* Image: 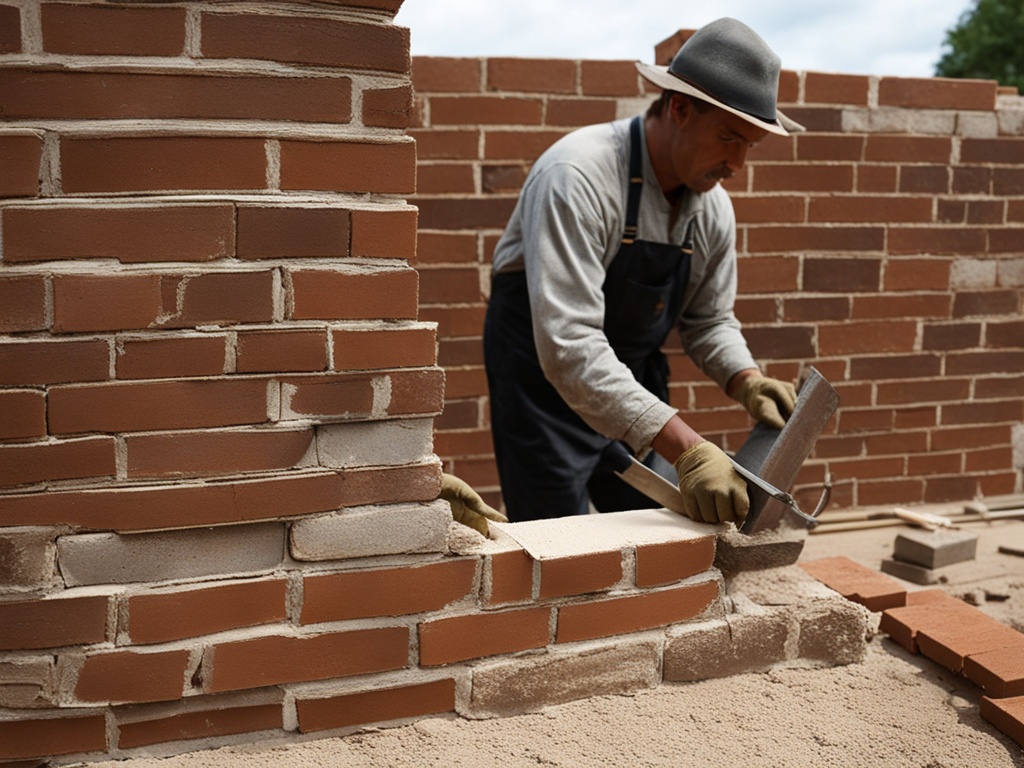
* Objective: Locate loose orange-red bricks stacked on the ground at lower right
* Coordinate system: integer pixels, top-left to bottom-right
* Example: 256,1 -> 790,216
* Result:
801,557 -> 1024,746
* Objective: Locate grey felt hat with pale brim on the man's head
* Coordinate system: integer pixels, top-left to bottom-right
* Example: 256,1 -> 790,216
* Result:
637,18 -> 804,136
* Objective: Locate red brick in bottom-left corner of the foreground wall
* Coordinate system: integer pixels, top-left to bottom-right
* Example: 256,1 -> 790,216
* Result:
0,714 -> 106,765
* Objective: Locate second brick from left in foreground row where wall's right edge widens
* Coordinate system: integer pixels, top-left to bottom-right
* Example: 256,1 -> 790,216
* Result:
116,335 -> 227,379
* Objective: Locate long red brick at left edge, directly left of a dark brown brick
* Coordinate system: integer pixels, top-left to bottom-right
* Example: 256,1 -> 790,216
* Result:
3,205 -> 234,263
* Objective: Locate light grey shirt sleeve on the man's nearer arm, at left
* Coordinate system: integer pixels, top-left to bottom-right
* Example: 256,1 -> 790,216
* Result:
521,163 -> 676,454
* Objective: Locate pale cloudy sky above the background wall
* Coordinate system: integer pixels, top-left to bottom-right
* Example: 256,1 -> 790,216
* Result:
395,0 -> 974,77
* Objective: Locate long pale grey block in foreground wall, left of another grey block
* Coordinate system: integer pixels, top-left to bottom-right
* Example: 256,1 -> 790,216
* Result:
57,522 -> 285,587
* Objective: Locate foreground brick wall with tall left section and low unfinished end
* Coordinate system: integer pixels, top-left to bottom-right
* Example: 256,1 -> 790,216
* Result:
0,6 -> 864,766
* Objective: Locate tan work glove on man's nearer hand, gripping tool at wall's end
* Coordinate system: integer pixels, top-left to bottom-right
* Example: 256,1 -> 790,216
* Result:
675,440 -> 751,523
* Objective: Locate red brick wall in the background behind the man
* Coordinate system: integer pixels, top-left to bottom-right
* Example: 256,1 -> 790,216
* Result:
411,46 -> 1024,507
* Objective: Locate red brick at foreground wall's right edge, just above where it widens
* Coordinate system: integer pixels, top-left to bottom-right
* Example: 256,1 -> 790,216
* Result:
289,269 -> 419,319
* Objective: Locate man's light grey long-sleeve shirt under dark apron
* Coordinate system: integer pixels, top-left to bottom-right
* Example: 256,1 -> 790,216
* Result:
494,120 -> 757,454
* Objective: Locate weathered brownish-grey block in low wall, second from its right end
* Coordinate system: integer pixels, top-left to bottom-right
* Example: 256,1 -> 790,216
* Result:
665,609 -> 790,682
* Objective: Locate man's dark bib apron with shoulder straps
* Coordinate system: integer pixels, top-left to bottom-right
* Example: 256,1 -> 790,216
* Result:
483,117 -> 693,521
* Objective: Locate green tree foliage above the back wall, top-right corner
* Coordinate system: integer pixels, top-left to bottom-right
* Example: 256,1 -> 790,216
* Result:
935,0 -> 1024,92
